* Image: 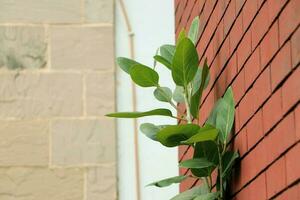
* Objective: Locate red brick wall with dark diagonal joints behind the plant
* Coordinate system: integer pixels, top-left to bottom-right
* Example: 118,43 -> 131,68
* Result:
175,0 -> 300,200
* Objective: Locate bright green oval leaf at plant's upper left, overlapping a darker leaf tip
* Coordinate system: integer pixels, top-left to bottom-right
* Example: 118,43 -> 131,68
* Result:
130,65 -> 159,87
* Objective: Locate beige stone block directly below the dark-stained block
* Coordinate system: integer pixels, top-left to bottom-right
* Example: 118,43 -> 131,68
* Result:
0,73 -> 83,119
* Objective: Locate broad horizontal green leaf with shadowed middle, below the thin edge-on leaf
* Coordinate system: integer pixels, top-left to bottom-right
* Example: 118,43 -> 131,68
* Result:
156,124 -> 200,147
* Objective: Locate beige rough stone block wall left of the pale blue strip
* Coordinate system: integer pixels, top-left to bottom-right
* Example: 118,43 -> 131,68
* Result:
0,0 -> 116,200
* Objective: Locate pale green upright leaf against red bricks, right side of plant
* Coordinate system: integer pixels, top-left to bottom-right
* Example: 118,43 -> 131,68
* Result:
216,88 -> 234,142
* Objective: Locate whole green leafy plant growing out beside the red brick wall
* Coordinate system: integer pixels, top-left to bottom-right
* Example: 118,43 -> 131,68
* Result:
106,17 -> 239,200
